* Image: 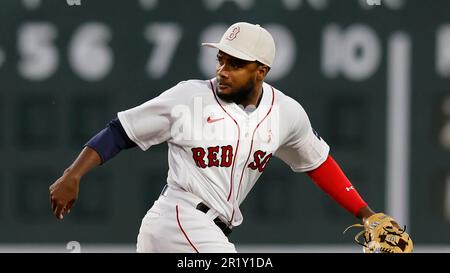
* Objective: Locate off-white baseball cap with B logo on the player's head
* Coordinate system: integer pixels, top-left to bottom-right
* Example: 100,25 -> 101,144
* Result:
202,22 -> 275,66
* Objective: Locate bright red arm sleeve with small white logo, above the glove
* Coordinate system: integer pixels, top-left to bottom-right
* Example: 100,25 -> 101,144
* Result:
306,155 -> 367,215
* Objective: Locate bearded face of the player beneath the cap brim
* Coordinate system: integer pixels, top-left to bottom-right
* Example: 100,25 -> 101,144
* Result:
216,51 -> 266,102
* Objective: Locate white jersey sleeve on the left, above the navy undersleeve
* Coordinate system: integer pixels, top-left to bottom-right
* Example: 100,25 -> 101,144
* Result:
117,83 -> 183,151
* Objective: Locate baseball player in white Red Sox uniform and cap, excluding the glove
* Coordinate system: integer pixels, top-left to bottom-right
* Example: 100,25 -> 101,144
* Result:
49,22 -> 374,252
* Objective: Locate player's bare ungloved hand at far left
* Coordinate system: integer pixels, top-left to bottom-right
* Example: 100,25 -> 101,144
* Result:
49,172 -> 80,220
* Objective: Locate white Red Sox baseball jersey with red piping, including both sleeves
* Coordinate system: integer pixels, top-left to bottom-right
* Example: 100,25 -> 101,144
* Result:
118,79 -> 329,226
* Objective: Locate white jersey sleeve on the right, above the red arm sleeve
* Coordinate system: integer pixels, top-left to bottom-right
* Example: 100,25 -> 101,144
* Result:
275,101 -> 330,172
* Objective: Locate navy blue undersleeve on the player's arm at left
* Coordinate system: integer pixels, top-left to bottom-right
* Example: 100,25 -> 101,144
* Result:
84,118 -> 137,164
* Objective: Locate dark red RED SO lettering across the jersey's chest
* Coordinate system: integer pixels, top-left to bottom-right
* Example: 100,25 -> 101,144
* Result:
191,145 -> 272,173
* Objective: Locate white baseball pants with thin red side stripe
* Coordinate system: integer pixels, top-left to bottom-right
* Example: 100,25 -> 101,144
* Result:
137,184 -> 236,253
